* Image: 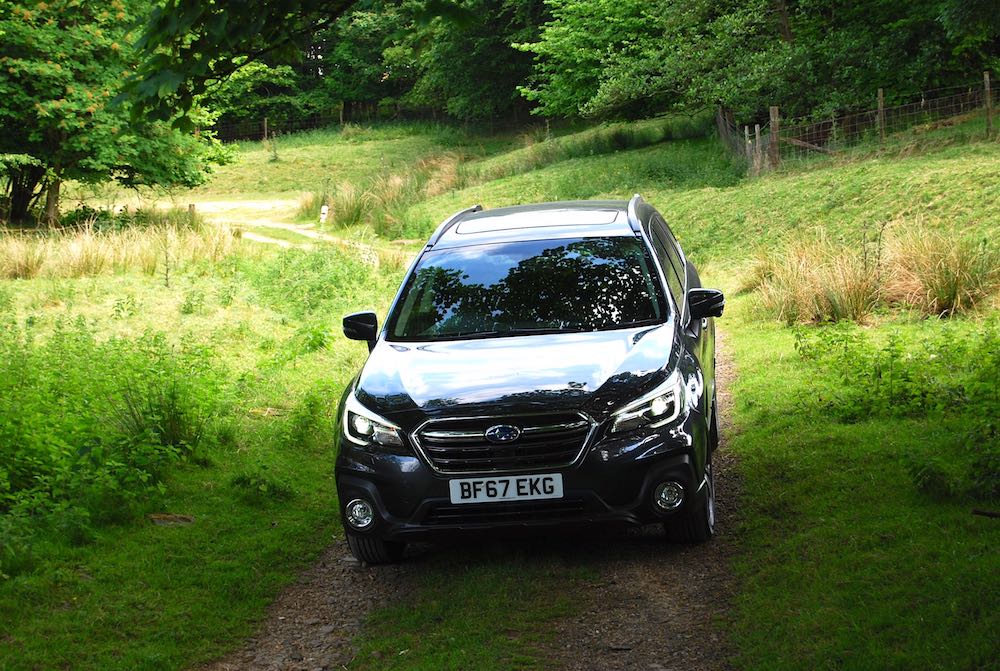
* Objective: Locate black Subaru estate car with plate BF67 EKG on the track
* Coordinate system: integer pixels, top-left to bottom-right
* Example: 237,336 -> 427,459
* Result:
336,195 -> 725,563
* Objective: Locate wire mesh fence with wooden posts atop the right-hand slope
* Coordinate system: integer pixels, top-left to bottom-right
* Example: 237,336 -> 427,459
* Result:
716,74 -> 1000,174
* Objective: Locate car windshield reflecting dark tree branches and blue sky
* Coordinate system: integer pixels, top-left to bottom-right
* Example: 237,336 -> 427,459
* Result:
389,237 -> 667,340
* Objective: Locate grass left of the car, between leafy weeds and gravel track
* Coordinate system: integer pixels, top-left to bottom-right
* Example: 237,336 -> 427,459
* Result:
0,249 -> 406,669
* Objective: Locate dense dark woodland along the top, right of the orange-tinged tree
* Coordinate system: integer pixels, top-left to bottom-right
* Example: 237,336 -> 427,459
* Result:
127,0 -> 1000,128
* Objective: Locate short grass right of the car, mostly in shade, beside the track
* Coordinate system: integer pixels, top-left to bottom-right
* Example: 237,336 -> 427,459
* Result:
726,299 -> 1000,670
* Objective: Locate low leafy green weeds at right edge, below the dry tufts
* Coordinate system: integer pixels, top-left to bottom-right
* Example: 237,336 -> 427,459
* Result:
795,320 -> 1000,500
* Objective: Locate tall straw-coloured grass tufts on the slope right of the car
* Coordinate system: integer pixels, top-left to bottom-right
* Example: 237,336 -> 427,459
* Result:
742,222 -> 1000,323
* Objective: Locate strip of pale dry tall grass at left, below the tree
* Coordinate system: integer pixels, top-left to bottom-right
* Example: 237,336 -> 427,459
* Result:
0,217 -> 239,279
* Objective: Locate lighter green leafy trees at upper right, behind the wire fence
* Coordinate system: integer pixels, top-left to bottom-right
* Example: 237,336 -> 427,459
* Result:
523,0 -> 1000,120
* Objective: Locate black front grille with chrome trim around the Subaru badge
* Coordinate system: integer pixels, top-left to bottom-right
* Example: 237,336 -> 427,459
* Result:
415,412 -> 591,473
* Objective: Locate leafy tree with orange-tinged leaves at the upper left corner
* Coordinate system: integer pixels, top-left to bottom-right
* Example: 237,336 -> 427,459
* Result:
0,0 -> 223,222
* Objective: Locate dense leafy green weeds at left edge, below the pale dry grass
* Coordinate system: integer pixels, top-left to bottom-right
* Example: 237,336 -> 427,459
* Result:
0,317 -> 223,573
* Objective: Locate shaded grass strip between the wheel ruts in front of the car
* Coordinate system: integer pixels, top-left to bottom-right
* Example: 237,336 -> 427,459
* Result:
350,546 -> 590,671
